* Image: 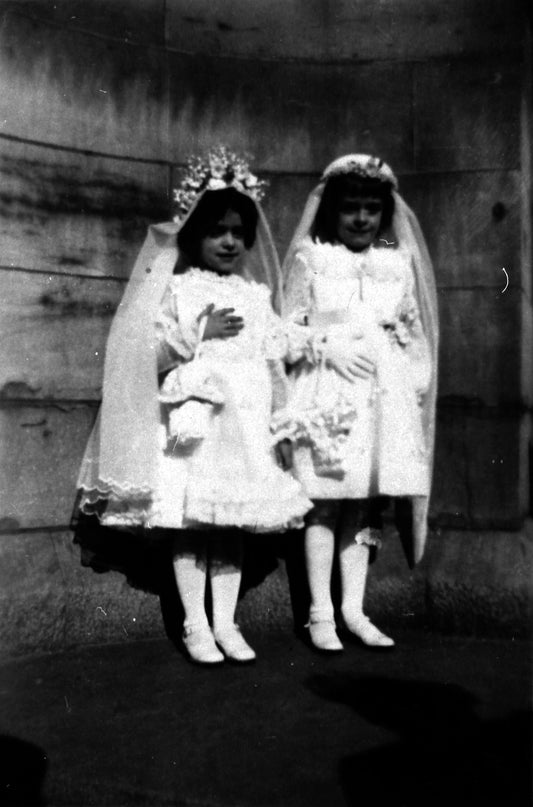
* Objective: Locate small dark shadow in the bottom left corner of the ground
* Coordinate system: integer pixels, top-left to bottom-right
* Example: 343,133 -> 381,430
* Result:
0,734 -> 48,807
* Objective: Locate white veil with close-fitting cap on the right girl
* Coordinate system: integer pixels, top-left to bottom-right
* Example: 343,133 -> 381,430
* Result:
281,154 -> 439,563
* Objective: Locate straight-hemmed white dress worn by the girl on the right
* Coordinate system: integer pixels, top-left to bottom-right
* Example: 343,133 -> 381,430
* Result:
278,237 -> 432,499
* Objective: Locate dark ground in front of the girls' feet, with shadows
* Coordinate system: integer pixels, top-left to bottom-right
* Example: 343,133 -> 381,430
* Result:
0,631 -> 532,807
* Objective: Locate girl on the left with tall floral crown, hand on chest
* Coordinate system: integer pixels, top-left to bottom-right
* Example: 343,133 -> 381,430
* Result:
79,147 -> 311,664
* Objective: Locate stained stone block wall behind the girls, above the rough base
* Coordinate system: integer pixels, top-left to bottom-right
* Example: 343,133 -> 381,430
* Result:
0,0 -> 531,652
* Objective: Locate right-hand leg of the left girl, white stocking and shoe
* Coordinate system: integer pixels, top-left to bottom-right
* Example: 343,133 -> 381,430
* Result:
209,531 -> 255,663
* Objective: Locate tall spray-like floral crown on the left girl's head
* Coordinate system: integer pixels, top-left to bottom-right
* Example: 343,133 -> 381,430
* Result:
174,146 -> 268,222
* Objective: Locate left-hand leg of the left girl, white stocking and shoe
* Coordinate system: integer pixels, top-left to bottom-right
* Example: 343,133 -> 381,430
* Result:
172,533 -> 224,664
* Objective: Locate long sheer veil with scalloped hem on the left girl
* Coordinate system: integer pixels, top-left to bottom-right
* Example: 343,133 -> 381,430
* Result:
77,190 -> 281,512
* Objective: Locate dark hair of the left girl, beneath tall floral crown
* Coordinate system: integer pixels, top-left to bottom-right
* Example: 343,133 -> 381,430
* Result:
178,188 -> 258,263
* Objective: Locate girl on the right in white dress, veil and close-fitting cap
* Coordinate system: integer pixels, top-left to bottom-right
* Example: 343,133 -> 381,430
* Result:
275,154 -> 437,651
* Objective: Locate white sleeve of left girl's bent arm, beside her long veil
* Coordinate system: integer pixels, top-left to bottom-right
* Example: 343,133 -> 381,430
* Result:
155,278 -> 201,373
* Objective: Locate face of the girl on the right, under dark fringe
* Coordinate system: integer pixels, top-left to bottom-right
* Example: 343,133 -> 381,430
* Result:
337,193 -> 383,252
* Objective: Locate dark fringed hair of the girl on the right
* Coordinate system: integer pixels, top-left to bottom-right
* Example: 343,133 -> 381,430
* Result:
311,174 -> 394,243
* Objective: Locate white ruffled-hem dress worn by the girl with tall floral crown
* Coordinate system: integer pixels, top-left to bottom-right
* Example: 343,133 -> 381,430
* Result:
101,268 -> 311,532
